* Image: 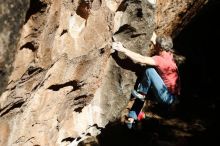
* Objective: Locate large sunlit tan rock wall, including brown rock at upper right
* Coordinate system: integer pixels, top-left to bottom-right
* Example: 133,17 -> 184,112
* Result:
0,0 -> 205,146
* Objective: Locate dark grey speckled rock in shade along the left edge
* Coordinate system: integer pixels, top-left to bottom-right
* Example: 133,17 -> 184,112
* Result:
0,0 -> 29,95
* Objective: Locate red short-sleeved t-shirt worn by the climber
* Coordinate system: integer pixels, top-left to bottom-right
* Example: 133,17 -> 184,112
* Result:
152,51 -> 180,95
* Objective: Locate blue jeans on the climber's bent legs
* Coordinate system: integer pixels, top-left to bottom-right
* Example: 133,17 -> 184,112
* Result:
137,68 -> 175,104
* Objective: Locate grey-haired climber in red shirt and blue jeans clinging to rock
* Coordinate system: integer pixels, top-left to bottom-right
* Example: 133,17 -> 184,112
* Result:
112,33 -> 180,128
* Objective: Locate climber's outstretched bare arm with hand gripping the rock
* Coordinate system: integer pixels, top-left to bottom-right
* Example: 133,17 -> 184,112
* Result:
112,42 -> 156,66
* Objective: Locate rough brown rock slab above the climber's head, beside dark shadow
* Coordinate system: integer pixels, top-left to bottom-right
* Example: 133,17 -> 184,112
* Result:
156,0 -> 208,37
